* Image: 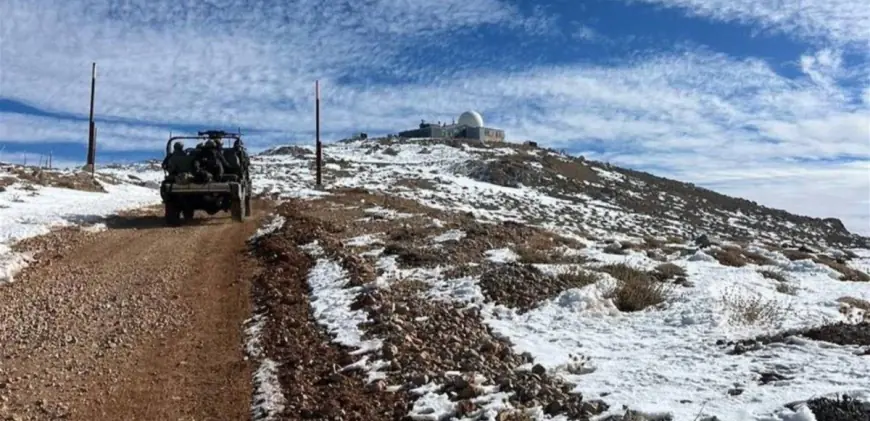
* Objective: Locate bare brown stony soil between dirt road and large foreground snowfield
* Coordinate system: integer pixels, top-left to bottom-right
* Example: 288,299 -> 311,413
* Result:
254,198 -> 607,420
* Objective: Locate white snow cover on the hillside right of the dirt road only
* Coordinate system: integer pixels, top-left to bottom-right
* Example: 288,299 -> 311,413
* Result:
254,141 -> 870,420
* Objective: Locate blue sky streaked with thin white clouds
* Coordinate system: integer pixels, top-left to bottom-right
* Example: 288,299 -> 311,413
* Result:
0,0 -> 870,234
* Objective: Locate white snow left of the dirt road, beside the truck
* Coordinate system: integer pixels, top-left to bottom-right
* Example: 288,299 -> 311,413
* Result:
0,174 -> 160,283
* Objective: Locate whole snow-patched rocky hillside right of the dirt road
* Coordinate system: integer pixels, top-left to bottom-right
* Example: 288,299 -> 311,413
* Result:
58,136 -> 870,421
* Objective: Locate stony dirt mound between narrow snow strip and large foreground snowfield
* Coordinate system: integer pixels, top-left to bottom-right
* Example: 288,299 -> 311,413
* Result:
368,281 -> 608,420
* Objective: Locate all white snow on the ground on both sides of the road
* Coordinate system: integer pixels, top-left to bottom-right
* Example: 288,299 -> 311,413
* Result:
0,142 -> 870,421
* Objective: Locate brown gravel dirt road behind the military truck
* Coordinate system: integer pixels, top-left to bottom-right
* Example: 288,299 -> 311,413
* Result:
0,204 -> 265,421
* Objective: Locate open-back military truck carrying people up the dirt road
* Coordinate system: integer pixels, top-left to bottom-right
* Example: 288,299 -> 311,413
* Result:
160,130 -> 251,226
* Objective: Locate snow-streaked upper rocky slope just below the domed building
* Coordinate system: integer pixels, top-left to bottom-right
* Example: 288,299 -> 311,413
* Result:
260,139 -> 868,249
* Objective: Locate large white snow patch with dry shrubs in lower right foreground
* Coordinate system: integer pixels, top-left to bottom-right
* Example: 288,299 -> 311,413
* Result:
483,251 -> 870,421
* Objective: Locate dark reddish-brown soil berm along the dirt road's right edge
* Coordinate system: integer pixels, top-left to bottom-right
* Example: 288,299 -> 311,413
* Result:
245,205 -> 410,421
